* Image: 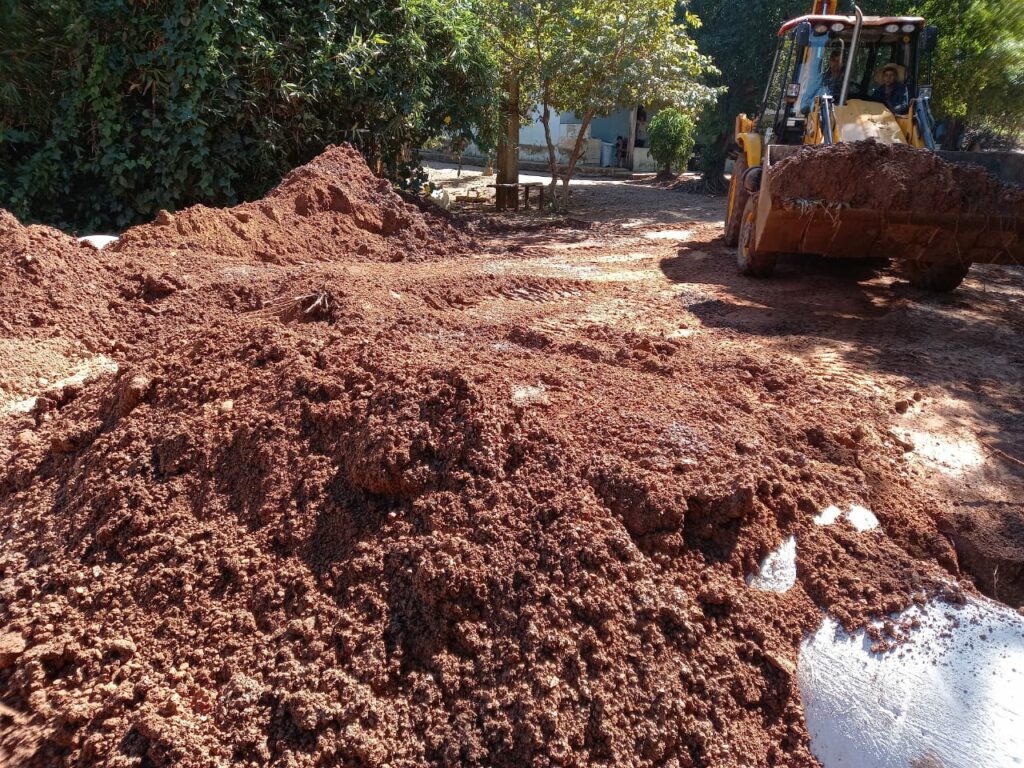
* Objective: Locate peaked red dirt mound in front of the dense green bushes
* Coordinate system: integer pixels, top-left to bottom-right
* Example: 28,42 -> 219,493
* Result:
0,145 -> 471,358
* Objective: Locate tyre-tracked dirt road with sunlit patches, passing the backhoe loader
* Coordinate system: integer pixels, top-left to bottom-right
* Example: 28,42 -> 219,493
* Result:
433,164 -> 1024,606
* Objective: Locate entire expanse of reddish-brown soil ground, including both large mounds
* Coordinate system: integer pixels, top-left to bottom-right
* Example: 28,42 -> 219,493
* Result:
0,147 -> 1024,768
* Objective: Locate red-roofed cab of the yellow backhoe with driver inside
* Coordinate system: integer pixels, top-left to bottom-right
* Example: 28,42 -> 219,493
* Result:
756,13 -> 936,148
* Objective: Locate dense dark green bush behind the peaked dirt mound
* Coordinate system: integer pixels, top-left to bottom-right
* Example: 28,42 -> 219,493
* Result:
0,0 -> 494,229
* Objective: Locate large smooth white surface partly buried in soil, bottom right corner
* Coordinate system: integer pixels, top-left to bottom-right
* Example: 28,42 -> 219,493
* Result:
797,599 -> 1024,768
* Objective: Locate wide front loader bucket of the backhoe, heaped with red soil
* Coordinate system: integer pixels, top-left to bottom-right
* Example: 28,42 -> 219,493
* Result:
754,141 -> 1024,272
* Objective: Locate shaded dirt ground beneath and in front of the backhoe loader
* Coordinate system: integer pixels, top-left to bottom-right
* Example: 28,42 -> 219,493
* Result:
662,243 -> 1024,606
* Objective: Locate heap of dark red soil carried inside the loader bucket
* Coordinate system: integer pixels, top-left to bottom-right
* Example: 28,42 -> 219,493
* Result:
770,140 -> 1024,214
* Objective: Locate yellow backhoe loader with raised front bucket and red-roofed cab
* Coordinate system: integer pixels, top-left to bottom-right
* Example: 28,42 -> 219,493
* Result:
726,0 -> 1024,291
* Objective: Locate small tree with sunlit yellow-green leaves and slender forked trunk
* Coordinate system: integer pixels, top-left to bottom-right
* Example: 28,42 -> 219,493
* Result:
543,0 -> 717,207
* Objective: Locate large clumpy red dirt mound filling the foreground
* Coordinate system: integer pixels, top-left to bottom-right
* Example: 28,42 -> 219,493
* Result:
0,309 -> 958,766
